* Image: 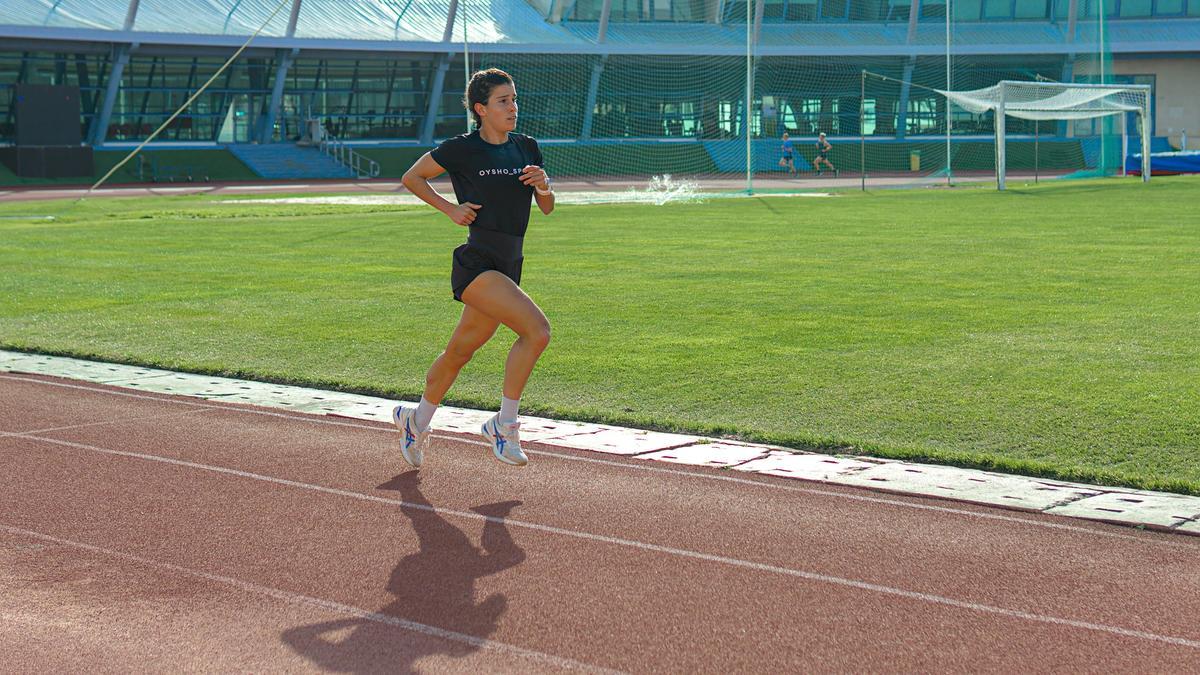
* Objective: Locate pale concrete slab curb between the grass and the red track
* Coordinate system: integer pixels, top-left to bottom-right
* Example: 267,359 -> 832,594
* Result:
0,351 -> 1200,536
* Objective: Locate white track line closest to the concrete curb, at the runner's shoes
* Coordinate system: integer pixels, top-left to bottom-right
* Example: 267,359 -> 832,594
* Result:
0,374 -> 1200,550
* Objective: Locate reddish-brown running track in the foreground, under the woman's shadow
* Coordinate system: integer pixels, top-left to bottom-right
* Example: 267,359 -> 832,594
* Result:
0,375 -> 1200,673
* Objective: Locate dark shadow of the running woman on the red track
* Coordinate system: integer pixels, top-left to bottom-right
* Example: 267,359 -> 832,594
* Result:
282,471 -> 526,673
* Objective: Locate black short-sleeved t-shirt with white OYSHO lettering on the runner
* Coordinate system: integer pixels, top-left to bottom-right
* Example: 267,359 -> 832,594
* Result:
430,130 -> 544,237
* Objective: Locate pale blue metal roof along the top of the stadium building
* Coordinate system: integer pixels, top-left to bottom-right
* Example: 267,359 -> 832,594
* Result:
0,0 -> 1200,56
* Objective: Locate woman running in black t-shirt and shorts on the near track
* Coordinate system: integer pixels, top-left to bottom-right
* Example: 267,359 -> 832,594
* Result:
391,68 -> 554,466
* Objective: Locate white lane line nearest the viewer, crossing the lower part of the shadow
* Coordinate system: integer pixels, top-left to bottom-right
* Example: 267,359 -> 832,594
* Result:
0,524 -> 620,673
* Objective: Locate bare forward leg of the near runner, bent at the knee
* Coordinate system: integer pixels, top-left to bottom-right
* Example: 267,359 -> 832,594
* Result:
458,270 -> 550,400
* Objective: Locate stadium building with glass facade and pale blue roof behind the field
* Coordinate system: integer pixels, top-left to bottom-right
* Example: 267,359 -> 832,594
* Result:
0,0 -> 1200,181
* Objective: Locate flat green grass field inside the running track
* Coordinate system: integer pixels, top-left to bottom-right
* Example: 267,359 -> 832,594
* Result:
0,178 -> 1200,494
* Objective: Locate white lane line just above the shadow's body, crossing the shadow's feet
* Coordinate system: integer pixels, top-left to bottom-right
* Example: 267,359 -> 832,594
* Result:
14,427 -> 1200,650
